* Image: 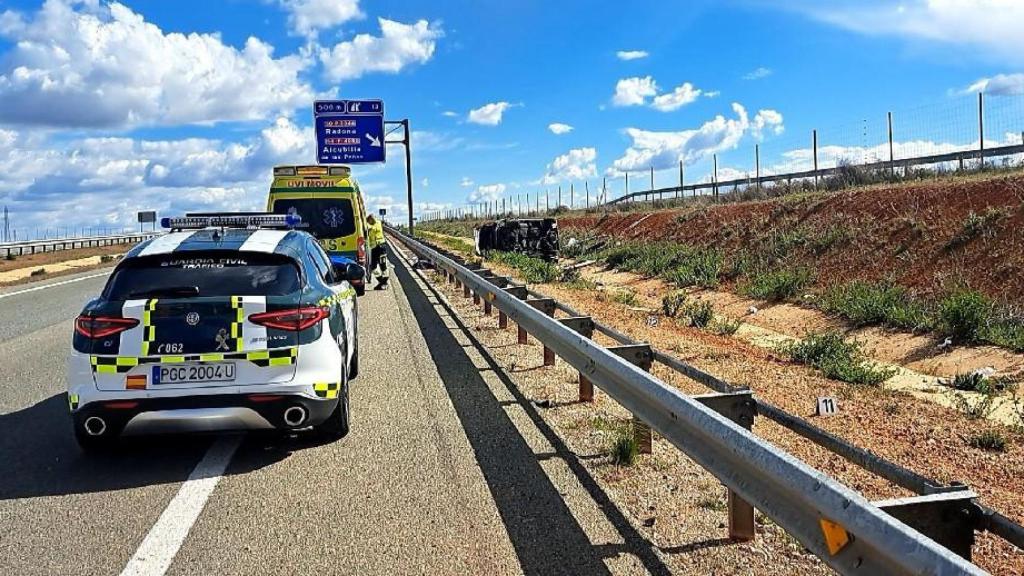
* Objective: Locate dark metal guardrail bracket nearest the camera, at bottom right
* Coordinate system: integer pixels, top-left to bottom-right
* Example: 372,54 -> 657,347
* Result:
871,486 -> 978,560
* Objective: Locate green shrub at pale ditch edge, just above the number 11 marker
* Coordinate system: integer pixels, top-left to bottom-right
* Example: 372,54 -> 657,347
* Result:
780,330 -> 895,385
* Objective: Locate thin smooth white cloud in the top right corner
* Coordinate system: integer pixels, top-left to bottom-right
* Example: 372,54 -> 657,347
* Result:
786,0 -> 1024,64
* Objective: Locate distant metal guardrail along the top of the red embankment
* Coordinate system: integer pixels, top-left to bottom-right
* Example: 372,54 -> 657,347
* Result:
596,145 -> 1024,206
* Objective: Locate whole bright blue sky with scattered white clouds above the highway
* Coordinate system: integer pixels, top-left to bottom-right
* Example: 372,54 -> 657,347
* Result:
0,0 -> 1024,234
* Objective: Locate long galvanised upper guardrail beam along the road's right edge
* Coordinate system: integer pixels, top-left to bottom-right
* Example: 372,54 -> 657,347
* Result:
389,229 -> 985,575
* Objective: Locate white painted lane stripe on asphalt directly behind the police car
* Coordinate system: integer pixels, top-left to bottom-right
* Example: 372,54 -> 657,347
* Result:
121,435 -> 242,576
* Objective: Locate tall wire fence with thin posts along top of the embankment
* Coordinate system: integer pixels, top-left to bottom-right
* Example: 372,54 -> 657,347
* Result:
423,93 -> 1024,220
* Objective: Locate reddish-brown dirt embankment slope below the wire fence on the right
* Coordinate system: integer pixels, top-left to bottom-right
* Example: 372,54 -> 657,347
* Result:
559,175 -> 1024,306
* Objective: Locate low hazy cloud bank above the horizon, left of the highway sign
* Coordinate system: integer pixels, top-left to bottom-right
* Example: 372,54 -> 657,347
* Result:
0,118 -> 313,231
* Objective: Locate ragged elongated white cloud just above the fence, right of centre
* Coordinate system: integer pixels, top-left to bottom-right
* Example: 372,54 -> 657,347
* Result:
608,102 -> 782,175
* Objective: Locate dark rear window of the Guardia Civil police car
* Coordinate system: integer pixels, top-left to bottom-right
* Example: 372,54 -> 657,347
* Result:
104,250 -> 302,300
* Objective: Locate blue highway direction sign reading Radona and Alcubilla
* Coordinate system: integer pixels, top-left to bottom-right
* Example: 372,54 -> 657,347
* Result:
313,100 -> 385,164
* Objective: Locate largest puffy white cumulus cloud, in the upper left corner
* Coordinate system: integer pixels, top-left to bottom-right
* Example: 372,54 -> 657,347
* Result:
0,0 -> 312,128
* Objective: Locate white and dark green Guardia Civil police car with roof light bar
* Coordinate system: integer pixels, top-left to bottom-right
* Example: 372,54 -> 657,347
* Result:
68,214 -> 365,450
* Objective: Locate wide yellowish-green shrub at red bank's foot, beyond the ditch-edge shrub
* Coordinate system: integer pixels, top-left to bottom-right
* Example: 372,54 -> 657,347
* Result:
818,281 -> 930,330
